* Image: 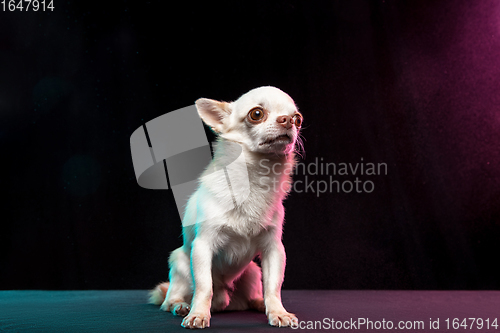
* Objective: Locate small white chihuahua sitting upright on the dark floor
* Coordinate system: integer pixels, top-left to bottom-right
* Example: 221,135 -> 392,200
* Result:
150,87 -> 302,328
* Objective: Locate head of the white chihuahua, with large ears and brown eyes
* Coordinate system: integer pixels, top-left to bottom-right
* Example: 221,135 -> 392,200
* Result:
196,87 -> 303,155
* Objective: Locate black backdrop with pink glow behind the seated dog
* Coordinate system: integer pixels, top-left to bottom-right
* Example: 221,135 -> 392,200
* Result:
0,0 -> 500,289
